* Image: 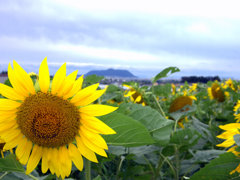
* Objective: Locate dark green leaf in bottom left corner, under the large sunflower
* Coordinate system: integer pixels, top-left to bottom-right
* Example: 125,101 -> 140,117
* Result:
0,154 -> 25,173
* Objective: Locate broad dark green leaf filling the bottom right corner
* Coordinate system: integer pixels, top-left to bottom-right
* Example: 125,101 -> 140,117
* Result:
191,153 -> 240,180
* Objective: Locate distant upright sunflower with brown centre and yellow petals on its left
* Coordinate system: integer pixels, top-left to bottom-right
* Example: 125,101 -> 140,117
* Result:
208,82 -> 227,102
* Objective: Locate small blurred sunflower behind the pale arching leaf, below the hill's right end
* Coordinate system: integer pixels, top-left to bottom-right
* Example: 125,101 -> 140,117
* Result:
123,84 -> 146,106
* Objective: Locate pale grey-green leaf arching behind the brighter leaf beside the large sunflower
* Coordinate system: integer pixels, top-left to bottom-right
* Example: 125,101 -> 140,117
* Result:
118,104 -> 174,145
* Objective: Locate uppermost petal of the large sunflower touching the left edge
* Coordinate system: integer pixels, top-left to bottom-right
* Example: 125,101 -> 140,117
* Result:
0,83 -> 25,100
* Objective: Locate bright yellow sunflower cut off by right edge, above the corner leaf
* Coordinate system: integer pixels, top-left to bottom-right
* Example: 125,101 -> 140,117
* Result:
217,123 -> 240,174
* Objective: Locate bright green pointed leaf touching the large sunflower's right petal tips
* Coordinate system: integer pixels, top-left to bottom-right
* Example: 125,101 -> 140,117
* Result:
100,112 -> 155,147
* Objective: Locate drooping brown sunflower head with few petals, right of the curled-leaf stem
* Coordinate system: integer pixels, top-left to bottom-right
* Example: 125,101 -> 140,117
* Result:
168,95 -> 196,128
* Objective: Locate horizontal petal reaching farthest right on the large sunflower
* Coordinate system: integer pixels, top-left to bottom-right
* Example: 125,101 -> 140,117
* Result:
79,104 -> 118,116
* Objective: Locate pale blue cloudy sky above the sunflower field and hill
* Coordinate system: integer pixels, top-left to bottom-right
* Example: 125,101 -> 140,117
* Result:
0,0 -> 240,79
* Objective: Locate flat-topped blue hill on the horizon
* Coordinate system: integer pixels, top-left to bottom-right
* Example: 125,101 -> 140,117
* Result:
86,69 -> 136,78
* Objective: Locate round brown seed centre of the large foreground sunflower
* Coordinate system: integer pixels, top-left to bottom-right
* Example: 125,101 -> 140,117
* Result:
17,92 -> 80,147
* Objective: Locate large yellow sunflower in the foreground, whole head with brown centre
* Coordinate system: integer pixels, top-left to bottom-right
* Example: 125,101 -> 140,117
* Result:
0,58 -> 117,178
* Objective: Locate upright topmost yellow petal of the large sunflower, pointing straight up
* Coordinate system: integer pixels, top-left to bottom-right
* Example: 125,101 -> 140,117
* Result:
38,57 -> 50,93
